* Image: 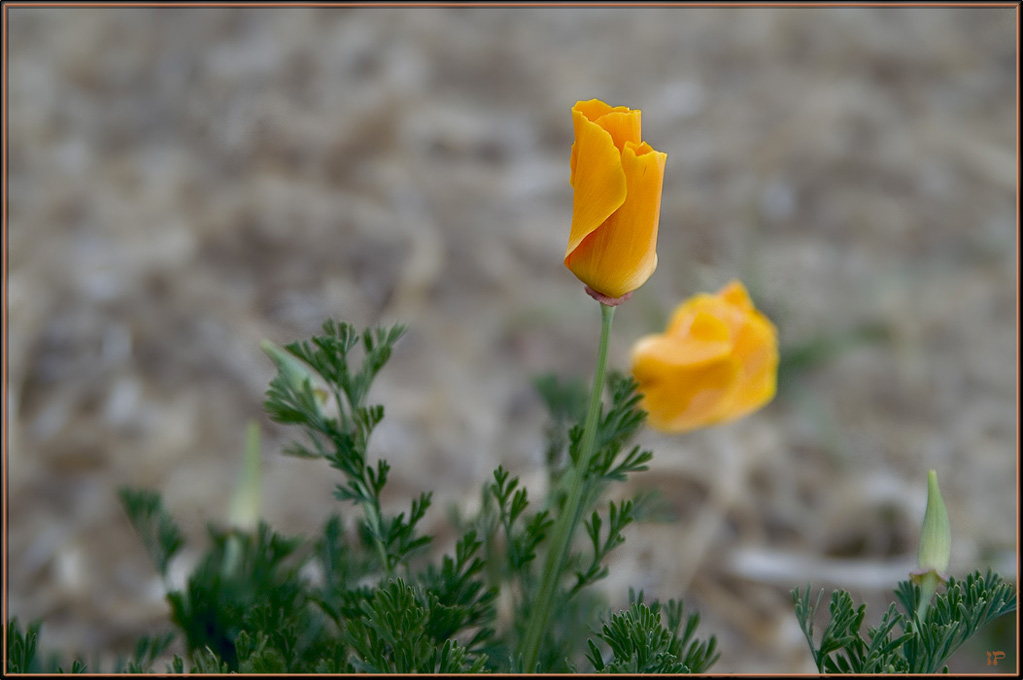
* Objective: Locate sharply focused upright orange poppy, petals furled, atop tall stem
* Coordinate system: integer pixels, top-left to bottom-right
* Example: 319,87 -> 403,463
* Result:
565,99 -> 668,298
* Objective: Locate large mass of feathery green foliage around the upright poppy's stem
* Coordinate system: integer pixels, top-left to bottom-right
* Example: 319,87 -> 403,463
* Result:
7,321 -> 716,675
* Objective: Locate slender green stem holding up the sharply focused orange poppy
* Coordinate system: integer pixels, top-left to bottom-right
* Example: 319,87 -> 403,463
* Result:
521,303 -> 615,673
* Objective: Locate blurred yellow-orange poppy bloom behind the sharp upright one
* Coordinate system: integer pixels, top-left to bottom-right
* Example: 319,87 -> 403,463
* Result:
632,280 -> 777,433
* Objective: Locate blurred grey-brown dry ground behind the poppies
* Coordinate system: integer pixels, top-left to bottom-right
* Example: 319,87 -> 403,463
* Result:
5,6 -> 1018,673
